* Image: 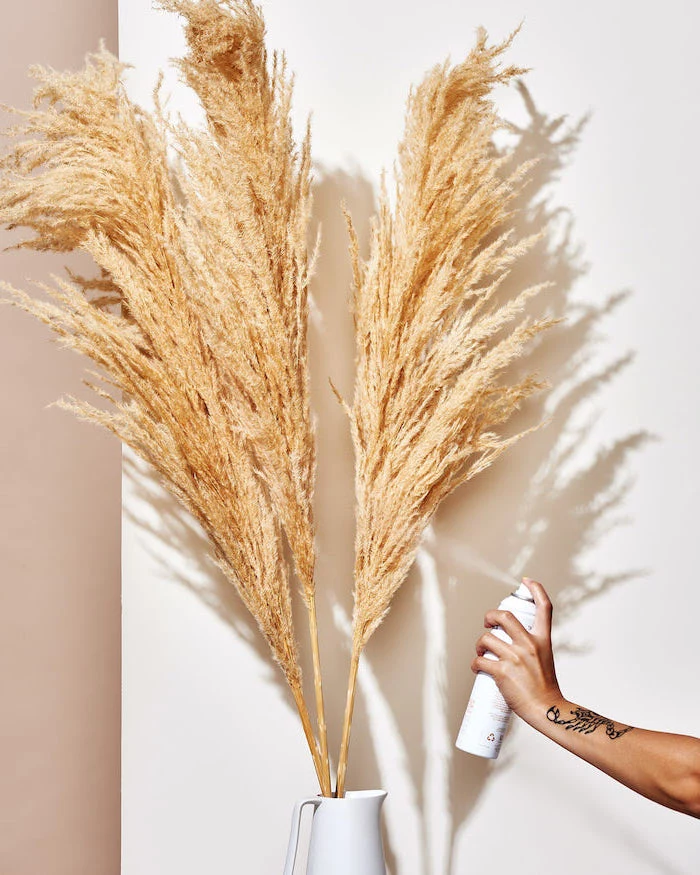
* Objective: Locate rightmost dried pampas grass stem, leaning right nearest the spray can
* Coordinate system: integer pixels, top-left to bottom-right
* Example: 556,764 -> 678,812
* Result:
337,29 -> 560,796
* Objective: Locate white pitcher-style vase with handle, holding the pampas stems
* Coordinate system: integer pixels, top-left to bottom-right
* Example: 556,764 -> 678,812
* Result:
284,790 -> 386,875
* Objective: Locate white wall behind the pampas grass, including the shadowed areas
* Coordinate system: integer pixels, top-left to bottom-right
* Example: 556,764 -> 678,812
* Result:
120,0 -> 700,875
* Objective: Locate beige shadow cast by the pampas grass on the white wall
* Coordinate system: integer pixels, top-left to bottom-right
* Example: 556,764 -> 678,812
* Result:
127,85 -> 653,875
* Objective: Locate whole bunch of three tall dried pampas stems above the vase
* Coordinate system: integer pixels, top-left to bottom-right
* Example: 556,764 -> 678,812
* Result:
0,0 -> 556,796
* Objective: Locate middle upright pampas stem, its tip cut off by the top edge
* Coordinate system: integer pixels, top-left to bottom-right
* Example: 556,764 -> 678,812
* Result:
160,0 -> 330,793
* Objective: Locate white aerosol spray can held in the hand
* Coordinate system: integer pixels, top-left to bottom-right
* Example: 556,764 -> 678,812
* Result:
456,583 -> 535,759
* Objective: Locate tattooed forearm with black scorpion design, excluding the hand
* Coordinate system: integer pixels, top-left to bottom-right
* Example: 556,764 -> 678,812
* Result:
520,696 -> 700,818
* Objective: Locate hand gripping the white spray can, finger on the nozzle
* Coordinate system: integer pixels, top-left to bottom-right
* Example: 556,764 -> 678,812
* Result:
471,577 -> 563,723
